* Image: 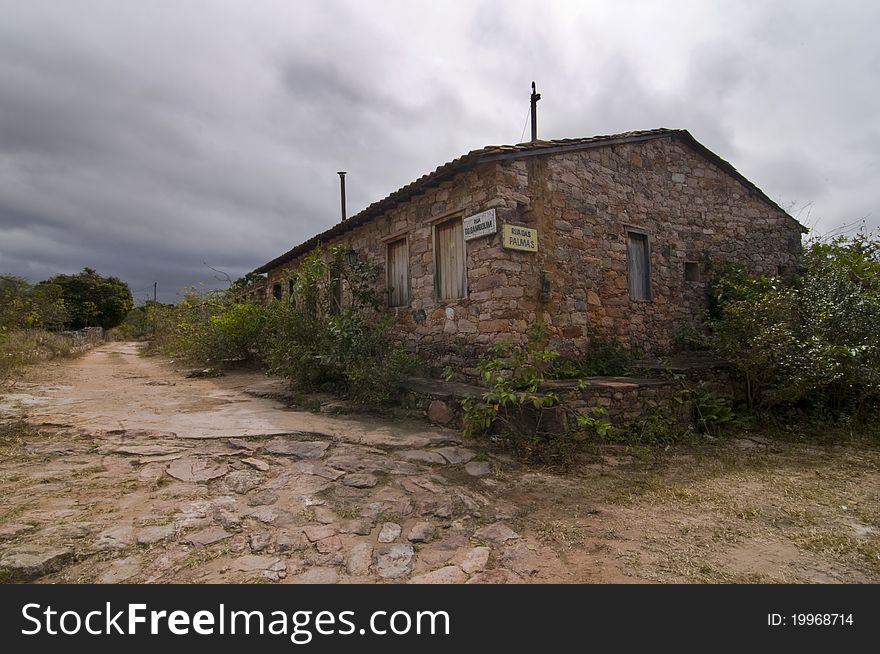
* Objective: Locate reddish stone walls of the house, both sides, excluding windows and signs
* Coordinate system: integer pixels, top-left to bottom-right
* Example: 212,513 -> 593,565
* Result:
266,138 -> 801,366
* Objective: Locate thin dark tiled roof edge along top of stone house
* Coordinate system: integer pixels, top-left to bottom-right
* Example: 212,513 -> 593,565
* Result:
254,128 -> 794,273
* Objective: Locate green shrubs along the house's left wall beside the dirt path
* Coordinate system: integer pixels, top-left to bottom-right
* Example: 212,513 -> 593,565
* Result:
147,245 -> 413,405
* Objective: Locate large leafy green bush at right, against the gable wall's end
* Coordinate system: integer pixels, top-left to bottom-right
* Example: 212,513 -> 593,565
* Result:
708,234 -> 880,419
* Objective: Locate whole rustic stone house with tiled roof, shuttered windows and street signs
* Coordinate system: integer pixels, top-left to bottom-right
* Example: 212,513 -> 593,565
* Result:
256,129 -> 805,358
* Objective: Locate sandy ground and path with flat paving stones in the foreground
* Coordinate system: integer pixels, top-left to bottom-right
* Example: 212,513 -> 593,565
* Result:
0,343 -> 880,583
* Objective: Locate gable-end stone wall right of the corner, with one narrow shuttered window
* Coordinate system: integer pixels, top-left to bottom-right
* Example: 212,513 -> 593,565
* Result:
514,139 -> 802,352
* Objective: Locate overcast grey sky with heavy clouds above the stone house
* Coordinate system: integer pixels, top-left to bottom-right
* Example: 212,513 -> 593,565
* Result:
0,0 -> 880,301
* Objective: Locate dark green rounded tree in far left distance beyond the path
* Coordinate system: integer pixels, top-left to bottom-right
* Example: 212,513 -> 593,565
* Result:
35,268 -> 134,329
